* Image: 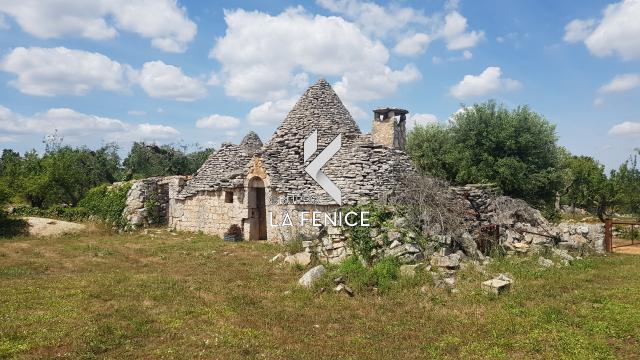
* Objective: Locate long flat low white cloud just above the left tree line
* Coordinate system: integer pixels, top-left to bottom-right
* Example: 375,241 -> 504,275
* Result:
0,105 -> 179,141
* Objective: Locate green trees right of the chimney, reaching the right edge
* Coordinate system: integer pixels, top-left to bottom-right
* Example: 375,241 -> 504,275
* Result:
407,101 -> 640,219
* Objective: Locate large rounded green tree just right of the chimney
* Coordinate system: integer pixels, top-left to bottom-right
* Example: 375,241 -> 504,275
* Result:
407,101 -> 561,207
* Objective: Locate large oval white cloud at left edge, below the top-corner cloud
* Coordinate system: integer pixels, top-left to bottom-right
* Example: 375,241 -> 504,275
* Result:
0,47 -> 131,96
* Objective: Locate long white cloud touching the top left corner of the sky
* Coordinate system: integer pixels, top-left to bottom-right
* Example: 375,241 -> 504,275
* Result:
0,0 -> 197,52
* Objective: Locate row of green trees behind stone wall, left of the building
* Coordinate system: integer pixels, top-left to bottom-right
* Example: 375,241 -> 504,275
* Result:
0,135 -> 213,208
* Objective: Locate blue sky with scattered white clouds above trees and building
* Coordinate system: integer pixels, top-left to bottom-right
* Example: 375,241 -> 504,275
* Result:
0,0 -> 640,168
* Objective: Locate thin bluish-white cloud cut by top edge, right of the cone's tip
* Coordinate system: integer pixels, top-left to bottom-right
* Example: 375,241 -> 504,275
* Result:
316,0 -> 429,36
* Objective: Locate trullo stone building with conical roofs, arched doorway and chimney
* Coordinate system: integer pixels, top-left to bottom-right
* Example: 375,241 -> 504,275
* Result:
167,80 -> 414,241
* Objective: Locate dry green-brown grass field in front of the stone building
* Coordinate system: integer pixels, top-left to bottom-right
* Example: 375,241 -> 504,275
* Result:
0,230 -> 640,359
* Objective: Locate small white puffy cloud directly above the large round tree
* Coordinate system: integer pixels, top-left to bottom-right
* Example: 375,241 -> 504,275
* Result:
451,66 -> 522,99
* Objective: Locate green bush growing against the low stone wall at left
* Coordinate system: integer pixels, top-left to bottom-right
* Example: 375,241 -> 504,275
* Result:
79,183 -> 132,228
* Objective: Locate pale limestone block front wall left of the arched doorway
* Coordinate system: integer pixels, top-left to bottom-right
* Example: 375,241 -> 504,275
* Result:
169,188 -> 248,237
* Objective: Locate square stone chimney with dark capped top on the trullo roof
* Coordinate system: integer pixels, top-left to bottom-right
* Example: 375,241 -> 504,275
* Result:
371,108 -> 409,150
